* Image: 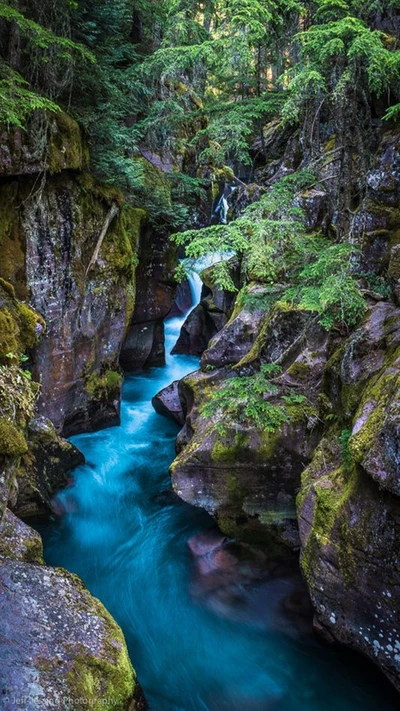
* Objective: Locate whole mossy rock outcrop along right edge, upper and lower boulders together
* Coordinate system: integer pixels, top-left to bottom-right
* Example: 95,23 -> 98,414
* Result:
298,303 -> 400,689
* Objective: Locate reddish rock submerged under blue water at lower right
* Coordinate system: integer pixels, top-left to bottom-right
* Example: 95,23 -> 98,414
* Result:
188,529 -> 312,637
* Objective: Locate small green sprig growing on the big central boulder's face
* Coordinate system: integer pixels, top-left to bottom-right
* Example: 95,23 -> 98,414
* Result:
200,363 -> 306,434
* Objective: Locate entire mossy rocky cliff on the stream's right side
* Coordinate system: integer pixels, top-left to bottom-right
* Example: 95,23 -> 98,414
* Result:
159,125 -> 400,688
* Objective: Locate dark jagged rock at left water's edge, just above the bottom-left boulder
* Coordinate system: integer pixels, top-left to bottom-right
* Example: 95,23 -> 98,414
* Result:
12,417 -> 85,518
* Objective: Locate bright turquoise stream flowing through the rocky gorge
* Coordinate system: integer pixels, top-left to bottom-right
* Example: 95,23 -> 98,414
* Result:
38,274 -> 395,711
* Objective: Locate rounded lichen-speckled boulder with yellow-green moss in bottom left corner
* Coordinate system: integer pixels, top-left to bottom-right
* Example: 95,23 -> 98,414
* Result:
0,560 -> 140,711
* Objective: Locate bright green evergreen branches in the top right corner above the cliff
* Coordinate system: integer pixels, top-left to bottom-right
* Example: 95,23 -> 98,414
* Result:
283,0 -> 400,121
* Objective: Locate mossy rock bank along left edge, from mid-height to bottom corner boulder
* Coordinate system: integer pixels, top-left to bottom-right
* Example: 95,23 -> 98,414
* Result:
0,280 -> 143,711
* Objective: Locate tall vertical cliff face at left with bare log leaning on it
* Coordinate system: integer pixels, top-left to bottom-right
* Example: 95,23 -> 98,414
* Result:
0,172 -> 145,435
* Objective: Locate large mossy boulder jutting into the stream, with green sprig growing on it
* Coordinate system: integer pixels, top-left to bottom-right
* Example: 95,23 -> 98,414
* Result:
171,303 -> 328,548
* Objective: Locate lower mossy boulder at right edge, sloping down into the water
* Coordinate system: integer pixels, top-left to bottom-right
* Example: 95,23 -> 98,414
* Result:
299,432 -> 400,690
